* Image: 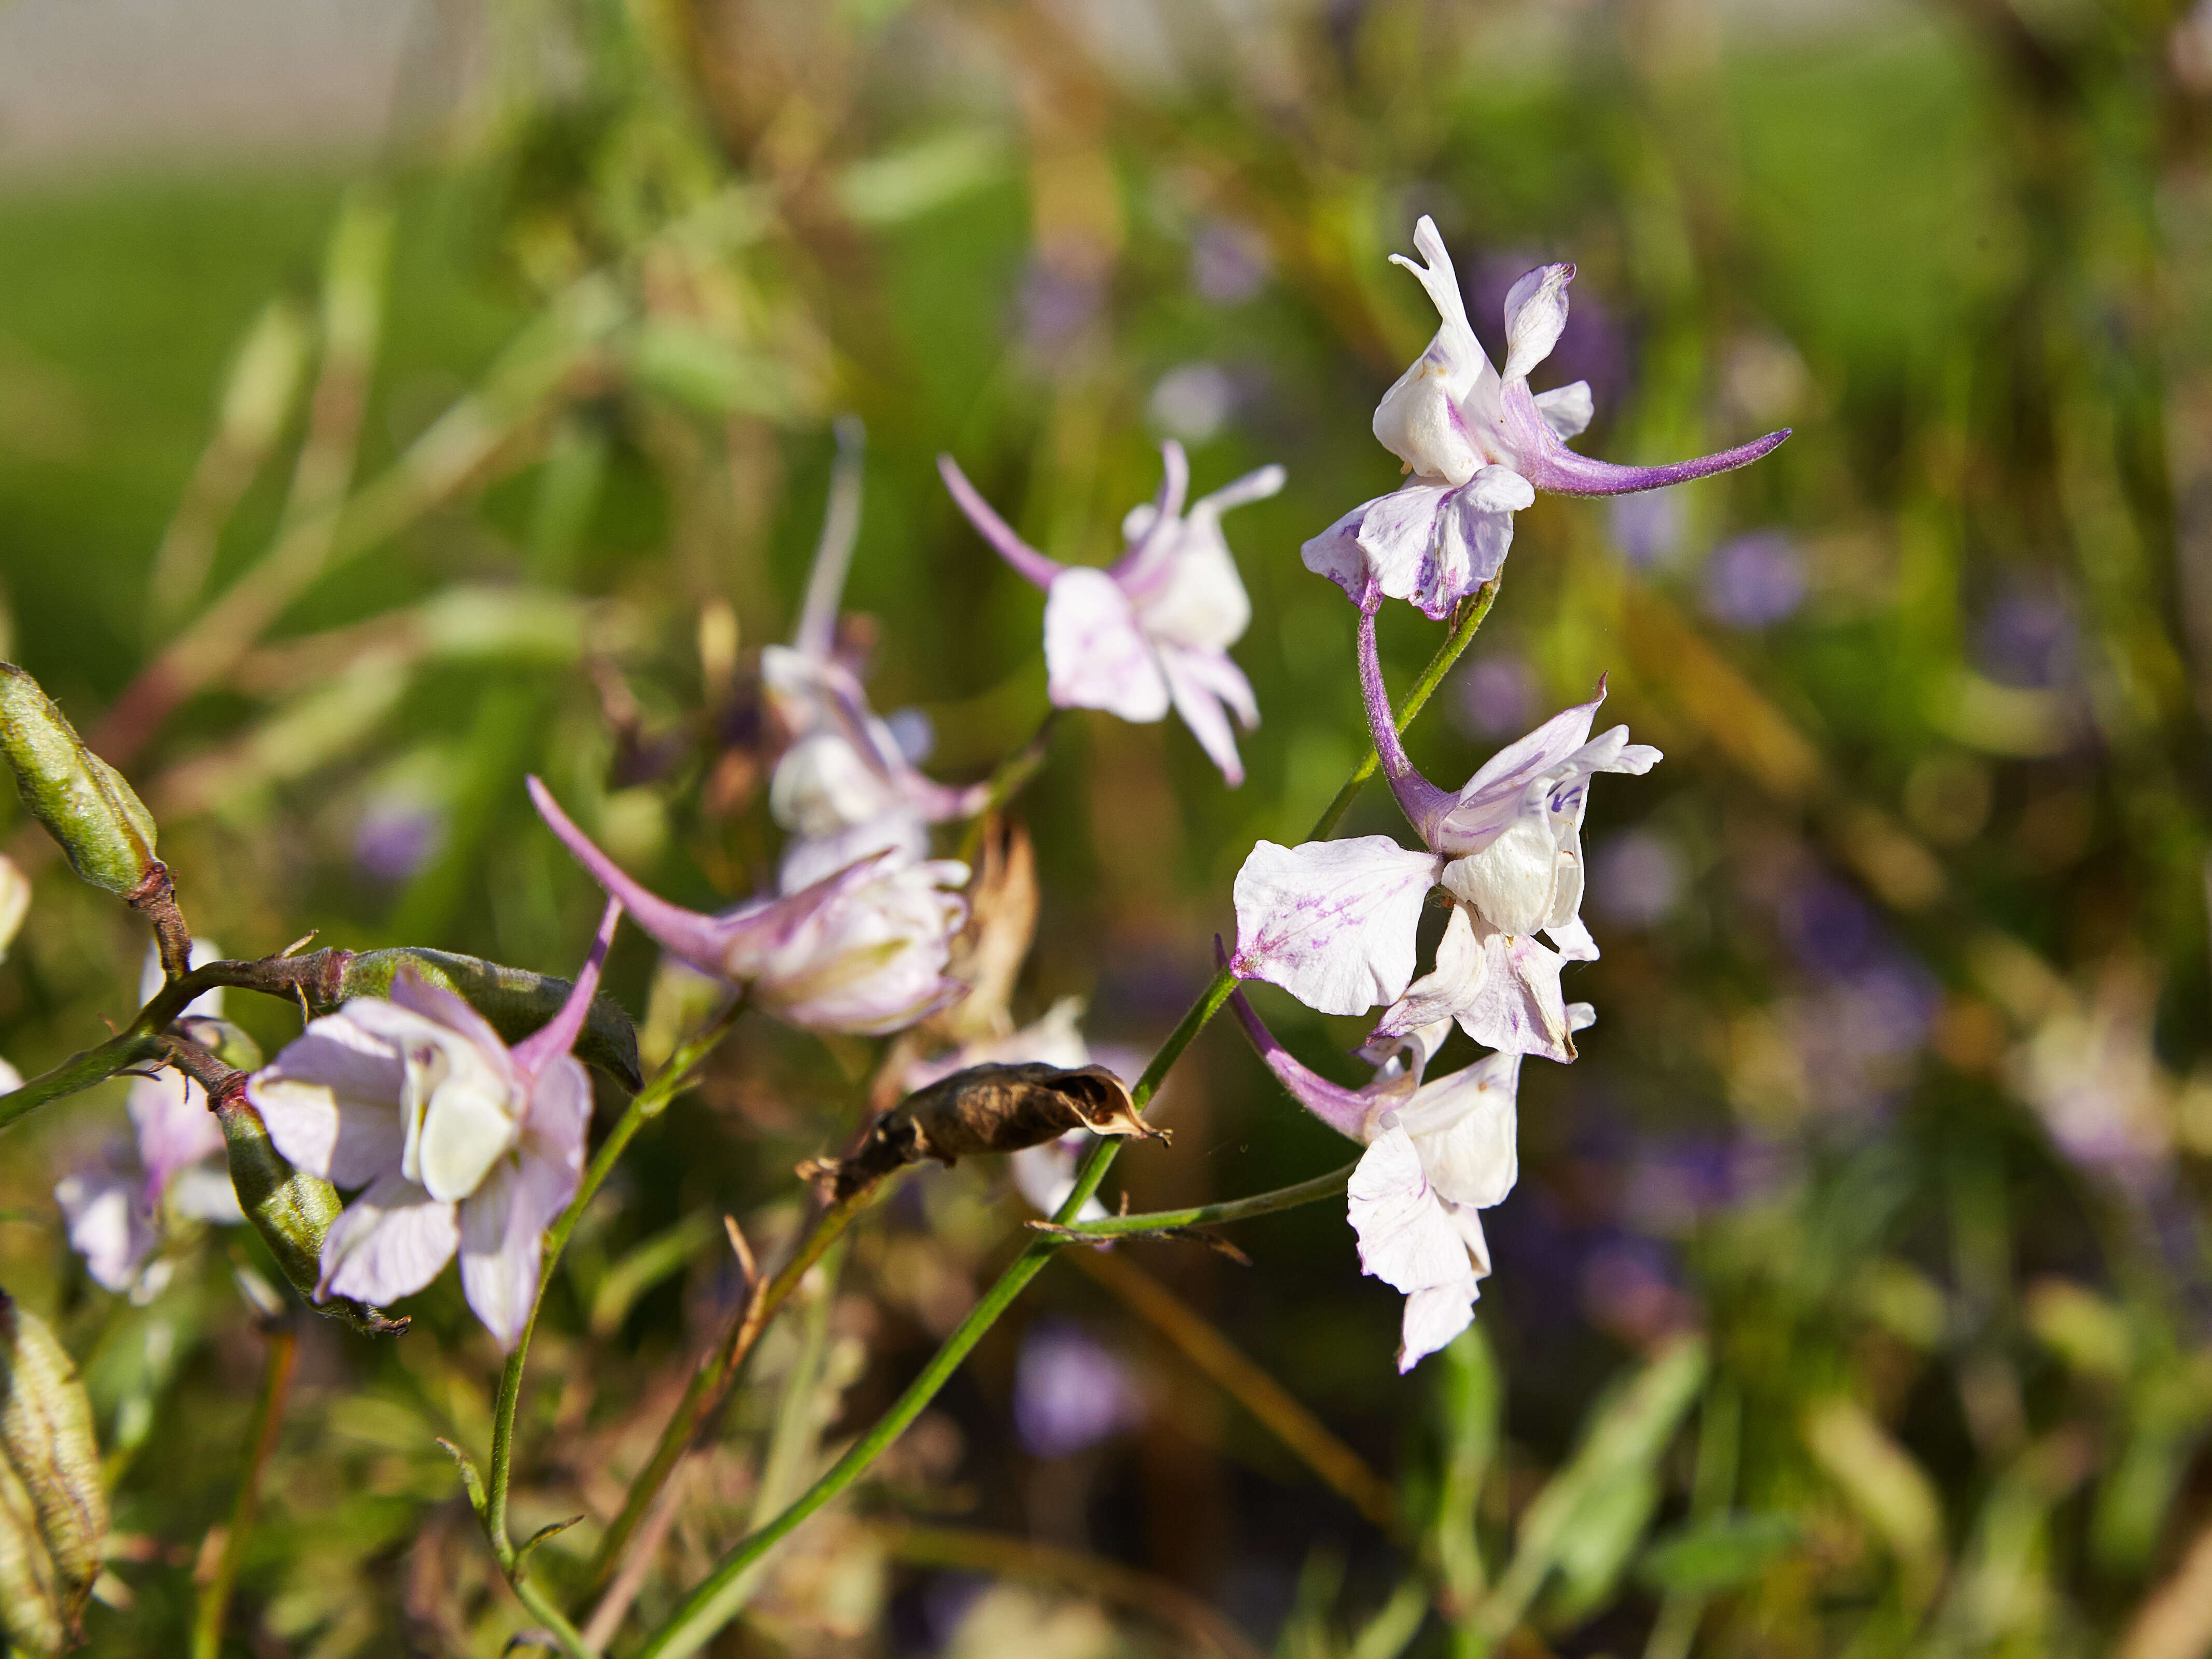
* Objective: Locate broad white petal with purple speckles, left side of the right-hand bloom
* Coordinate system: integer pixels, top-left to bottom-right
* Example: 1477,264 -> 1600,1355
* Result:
1234,836 -> 1435,1013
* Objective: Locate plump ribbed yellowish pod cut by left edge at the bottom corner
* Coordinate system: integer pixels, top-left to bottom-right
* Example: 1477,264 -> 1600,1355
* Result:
0,1292 -> 108,1659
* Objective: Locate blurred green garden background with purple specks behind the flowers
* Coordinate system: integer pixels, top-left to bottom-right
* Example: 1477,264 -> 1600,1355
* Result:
0,0 -> 2212,1659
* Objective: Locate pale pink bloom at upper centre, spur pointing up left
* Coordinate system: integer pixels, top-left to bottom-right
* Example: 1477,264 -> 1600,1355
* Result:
938,440 -> 1283,785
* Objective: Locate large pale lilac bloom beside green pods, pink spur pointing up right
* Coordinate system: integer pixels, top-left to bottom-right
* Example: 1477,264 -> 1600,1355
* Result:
245,903 -> 621,1349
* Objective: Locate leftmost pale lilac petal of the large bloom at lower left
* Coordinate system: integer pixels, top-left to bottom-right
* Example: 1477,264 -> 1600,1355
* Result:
245,1000 -> 407,1188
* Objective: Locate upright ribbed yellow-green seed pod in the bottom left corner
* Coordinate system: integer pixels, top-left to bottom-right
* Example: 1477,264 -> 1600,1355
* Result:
0,1292 -> 108,1630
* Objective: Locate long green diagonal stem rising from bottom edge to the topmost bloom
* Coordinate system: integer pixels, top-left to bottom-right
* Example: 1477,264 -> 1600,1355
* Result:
637,582 -> 1498,1659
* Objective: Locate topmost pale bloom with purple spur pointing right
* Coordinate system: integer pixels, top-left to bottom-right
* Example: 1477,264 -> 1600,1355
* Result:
1305,215 -> 1790,617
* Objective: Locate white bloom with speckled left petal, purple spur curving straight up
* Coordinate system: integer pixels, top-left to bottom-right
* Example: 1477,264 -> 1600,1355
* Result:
1232,613 -> 1659,1059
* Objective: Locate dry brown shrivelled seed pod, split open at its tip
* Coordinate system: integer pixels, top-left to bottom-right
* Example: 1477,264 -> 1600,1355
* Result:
798,1062 -> 1168,1199
